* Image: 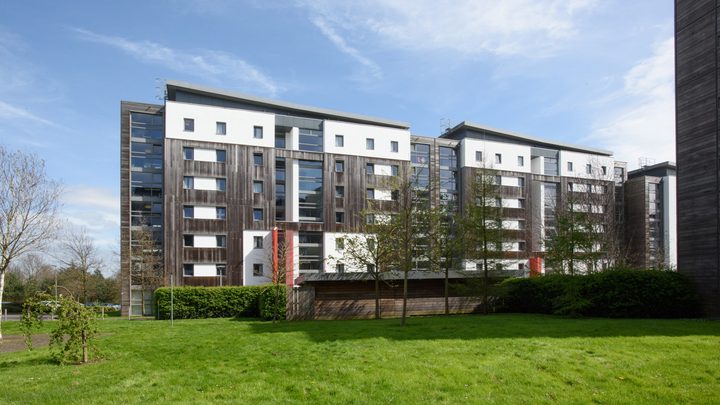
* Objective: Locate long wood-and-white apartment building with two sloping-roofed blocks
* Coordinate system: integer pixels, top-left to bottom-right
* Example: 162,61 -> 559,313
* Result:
121,82 -> 614,315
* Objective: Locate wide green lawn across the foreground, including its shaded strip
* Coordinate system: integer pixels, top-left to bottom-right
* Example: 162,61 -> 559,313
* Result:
0,315 -> 720,405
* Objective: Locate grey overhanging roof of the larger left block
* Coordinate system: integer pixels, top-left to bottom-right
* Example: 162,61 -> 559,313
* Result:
165,80 -> 410,129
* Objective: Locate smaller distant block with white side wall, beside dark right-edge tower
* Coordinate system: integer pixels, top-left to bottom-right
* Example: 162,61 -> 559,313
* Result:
624,162 -> 677,268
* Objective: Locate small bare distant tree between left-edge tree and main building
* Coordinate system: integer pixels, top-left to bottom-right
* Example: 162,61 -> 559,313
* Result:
61,228 -> 103,304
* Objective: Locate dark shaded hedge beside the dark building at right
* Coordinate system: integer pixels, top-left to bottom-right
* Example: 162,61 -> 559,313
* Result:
501,269 -> 700,318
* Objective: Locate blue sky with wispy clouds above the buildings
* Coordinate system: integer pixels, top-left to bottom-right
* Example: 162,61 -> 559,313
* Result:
0,0 -> 675,268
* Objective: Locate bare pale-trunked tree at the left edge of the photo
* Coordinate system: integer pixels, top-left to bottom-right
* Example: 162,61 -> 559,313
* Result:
0,146 -> 61,341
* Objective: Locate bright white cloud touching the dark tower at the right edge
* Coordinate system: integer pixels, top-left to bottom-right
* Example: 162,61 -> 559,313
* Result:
590,38 -> 675,169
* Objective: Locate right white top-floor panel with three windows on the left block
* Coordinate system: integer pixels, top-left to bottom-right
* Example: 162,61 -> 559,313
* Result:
323,120 -> 410,161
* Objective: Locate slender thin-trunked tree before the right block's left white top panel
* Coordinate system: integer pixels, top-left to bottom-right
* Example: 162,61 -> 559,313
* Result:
459,168 -> 505,314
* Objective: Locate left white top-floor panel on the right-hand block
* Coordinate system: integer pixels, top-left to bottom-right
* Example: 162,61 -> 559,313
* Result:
460,138 -> 530,173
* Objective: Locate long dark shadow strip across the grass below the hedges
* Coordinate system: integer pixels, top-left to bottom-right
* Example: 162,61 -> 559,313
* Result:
249,314 -> 720,341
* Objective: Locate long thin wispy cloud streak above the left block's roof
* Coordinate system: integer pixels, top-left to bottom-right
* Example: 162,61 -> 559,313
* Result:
72,28 -> 282,96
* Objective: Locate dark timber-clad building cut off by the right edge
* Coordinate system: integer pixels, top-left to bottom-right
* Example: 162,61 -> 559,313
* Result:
675,0 -> 720,317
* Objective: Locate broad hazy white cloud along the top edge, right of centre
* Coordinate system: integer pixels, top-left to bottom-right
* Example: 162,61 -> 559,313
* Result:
298,0 -> 596,58
